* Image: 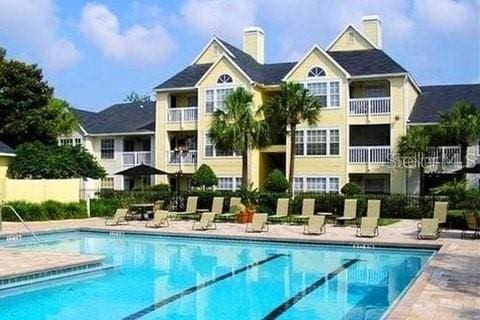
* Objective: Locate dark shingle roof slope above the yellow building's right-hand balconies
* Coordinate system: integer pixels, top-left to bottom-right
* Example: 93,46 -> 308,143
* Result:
328,49 -> 407,76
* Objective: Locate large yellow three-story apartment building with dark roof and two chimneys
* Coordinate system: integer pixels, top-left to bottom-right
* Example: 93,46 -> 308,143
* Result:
152,16 -> 480,193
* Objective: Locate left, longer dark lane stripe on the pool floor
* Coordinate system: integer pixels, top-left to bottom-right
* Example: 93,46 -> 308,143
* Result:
123,253 -> 288,320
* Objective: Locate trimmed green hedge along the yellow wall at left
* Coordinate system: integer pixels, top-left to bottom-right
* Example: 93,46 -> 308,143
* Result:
2,201 -> 87,221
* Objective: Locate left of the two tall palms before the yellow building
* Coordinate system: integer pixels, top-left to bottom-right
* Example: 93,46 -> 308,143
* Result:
209,87 -> 269,187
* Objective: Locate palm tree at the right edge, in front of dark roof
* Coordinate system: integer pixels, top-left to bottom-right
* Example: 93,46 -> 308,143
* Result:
438,102 -> 480,167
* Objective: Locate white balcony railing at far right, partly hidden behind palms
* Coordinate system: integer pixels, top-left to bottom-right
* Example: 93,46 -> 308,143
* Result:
427,146 -> 462,171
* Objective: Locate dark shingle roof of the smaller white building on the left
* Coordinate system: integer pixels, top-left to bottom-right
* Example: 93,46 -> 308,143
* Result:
74,102 -> 155,134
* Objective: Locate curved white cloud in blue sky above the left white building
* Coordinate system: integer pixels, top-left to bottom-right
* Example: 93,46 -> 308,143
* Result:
80,3 -> 175,65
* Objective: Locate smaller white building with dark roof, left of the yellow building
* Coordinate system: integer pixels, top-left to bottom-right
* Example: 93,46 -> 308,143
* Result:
62,102 -> 155,192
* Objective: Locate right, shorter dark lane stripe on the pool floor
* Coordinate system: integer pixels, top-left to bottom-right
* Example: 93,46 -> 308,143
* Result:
262,259 -> 360,320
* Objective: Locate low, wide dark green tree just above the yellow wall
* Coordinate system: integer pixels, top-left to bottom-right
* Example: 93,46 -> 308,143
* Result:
8,142 -> 106,179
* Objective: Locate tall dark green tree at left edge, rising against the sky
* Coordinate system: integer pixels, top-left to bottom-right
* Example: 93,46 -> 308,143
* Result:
0,50 -> 77,147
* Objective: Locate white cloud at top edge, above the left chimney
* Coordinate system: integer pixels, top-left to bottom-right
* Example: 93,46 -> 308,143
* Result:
180,0 -> 256,39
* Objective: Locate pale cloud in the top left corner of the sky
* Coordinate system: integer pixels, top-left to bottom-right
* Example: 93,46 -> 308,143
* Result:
0,0 -> 81,70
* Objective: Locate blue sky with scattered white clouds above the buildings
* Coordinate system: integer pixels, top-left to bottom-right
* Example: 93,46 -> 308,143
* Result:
0,0 -> 480,111
